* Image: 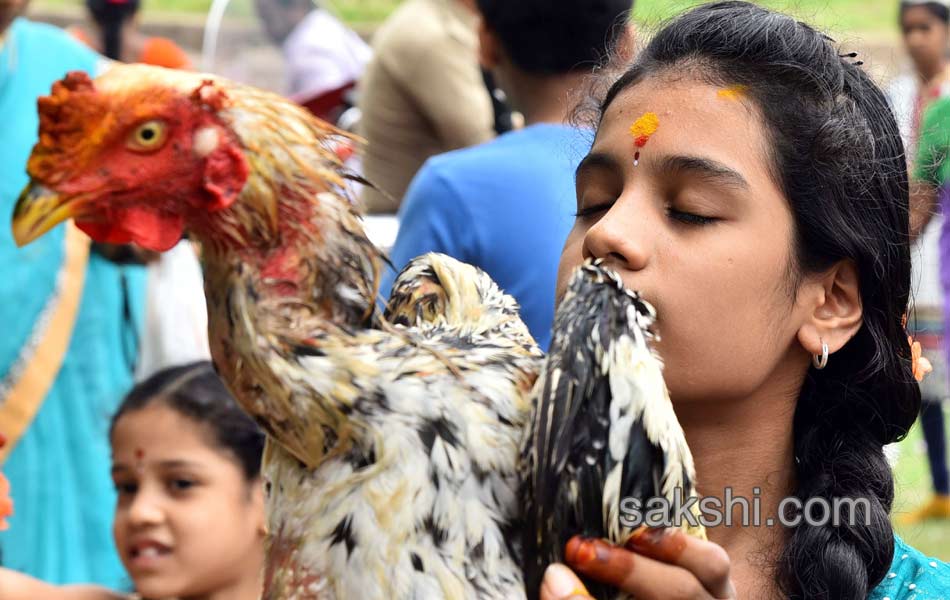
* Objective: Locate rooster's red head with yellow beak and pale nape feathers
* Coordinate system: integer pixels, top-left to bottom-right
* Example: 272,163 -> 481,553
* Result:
13,65 -> 356,251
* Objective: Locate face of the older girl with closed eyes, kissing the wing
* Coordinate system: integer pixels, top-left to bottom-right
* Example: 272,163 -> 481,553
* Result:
558,77 -> 809,404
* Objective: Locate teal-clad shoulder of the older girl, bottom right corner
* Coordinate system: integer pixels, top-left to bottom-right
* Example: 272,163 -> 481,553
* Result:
868,535 -> 950,600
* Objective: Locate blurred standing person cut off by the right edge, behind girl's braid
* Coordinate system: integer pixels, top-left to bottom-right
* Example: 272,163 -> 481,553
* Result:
888,0 -> 950,525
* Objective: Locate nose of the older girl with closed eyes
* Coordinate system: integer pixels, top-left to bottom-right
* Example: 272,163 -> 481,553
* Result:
583,198 -> 655,271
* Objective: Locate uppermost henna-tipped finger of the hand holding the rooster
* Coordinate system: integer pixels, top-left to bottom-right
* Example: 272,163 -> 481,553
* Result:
626,527 -> 735,598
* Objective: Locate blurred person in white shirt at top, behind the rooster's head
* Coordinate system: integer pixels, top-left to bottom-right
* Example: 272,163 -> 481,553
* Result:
255,0 -> 372,123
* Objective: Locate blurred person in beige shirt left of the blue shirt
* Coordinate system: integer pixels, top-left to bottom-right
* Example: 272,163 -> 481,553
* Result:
359,0 -> 494,213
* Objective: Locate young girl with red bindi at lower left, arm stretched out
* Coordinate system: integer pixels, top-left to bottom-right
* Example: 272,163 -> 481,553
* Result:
0,362 -> 265,600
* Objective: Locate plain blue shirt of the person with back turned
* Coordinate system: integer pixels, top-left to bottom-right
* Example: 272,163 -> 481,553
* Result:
380,124 -> 592,351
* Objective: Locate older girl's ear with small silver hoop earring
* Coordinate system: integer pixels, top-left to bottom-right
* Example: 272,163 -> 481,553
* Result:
798,260 -> 864,360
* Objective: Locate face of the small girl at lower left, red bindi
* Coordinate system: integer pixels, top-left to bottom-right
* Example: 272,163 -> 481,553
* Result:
112,402 -> 264,598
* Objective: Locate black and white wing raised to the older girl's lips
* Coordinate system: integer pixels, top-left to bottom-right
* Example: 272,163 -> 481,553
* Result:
521,262 -> 704,598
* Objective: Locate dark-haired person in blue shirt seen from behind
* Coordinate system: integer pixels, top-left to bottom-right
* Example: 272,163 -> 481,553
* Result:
380,0 -> 632,350
